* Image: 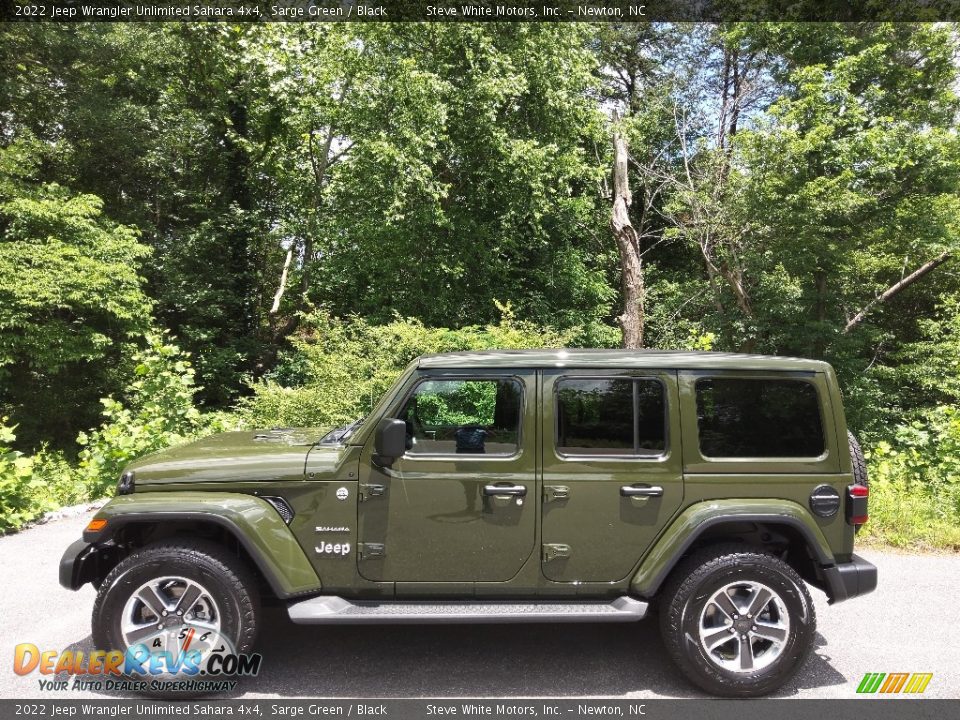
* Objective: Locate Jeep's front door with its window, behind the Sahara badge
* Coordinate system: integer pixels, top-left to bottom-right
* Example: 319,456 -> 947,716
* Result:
358,371 -> 537,593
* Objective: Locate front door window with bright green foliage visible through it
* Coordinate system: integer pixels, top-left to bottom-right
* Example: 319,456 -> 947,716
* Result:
398,379 -> 523,455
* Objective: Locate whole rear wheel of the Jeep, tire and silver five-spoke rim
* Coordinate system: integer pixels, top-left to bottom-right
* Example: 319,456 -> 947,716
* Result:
660,545 -> 816,697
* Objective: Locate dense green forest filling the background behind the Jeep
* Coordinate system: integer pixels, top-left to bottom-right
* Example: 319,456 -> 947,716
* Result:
0,23 -> 960,551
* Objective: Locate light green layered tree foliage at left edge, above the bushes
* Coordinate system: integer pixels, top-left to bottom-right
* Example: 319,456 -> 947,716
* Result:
0,139 -> 151,447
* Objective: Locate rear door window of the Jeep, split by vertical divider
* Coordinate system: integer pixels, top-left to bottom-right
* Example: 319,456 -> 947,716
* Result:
556,378 -> 666,455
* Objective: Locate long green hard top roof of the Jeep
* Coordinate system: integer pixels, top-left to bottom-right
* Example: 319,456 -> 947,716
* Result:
417,348 -> 830,372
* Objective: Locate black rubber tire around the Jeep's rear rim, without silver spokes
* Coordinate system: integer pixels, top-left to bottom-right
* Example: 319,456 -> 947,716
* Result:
660,544 -> 817,697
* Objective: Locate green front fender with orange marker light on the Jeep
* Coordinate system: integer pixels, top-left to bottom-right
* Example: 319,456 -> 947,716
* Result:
76,491 -> 321,598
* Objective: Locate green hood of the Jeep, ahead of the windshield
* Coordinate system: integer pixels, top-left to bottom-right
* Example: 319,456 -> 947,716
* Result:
126,428 -> 345,487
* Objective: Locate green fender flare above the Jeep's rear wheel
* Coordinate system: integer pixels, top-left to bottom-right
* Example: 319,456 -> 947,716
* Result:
630,498 -> 834,597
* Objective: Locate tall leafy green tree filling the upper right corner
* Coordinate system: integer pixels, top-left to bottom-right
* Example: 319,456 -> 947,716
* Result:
735,24 -> 960,366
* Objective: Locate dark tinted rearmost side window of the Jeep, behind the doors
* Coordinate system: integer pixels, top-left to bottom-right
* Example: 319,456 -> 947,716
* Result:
697,378 -> 825,458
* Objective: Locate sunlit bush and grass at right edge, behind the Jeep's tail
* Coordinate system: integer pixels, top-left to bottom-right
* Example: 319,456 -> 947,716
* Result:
864,406 -> 960,550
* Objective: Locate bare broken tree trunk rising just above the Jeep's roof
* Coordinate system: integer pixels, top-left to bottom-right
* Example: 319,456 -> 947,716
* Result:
610,113 -> 646,348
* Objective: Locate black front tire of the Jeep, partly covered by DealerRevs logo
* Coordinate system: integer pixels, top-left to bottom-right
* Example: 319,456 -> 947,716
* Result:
92,539 -> 260,697
